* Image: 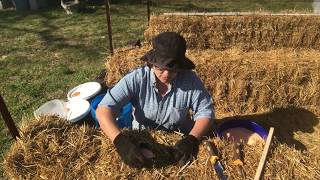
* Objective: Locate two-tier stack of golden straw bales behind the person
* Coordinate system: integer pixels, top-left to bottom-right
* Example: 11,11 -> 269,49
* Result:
106,15 -> 320,116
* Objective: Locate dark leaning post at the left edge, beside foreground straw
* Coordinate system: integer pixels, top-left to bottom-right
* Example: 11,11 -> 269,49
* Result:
0,95 -> 20,140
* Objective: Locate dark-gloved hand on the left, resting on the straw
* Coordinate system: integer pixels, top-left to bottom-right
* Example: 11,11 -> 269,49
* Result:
113,133 -> 146,168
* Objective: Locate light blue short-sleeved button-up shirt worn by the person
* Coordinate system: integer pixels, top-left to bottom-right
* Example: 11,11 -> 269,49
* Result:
99,66 -> 214,133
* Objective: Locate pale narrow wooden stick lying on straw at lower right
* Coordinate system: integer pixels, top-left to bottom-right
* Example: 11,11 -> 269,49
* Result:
254,127 -> 274,180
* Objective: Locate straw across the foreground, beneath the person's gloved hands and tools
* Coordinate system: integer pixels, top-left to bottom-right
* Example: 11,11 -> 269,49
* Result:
3,117 -> 320,179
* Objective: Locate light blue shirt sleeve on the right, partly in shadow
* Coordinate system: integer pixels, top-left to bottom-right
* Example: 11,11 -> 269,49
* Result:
192,75 -> 214,120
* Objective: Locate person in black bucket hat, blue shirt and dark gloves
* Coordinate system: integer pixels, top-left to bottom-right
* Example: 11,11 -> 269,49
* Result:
97,32 -> 214,167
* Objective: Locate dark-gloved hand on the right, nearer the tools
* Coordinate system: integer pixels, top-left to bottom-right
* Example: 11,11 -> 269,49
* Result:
174,134 -> 200,166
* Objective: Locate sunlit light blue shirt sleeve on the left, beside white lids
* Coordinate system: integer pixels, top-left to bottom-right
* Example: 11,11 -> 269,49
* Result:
99,71 -> 136,115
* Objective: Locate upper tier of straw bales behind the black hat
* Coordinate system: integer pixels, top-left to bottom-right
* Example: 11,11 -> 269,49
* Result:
144,14 -> 320,50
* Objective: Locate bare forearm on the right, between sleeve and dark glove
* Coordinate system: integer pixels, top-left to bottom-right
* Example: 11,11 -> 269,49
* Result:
189,117 -> 213,140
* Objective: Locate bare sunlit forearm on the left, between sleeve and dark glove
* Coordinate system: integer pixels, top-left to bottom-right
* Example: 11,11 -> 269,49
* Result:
97,106 -> 121,142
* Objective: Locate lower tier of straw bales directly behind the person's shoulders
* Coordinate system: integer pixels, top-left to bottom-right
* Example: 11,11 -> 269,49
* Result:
106,44 -> 320,117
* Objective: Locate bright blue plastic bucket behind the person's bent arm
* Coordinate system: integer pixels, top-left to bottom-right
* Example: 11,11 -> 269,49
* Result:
90,93 -> 132,128
